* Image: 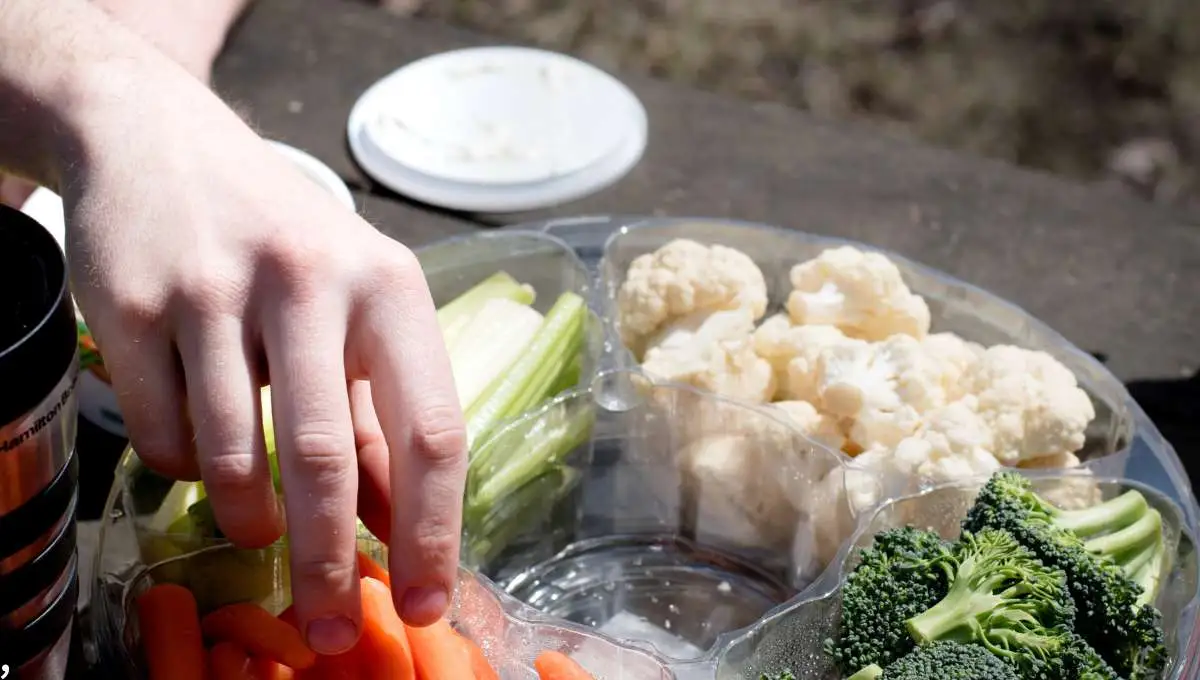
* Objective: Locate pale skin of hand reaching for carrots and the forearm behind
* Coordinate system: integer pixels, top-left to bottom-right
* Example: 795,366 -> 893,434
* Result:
0,0 -> 466,654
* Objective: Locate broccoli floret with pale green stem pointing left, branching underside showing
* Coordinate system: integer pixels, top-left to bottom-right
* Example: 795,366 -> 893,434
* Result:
906,529 -> 1075,678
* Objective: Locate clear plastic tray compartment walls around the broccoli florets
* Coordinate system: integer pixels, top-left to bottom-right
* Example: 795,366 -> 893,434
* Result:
716,473 -> 1200,680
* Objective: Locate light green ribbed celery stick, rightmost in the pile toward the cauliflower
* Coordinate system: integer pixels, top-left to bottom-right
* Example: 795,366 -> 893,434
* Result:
467,293 -> 587,449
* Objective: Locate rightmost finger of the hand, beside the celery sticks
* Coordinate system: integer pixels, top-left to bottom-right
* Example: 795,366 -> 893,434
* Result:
352,254 -> 467,626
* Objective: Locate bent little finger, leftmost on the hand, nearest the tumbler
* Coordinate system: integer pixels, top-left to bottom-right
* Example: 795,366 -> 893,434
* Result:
102,326 -> 200,481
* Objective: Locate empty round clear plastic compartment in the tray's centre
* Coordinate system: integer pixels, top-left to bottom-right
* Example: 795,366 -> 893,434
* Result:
463,371 -> 853,660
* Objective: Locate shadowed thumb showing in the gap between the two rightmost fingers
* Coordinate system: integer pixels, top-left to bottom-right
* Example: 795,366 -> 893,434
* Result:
349,380 -> 391,540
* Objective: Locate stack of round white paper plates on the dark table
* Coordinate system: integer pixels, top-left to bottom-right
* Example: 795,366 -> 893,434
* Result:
347,47 -> 647,212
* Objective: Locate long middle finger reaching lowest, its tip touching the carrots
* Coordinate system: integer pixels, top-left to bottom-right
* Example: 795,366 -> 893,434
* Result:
263,294 -> 362,654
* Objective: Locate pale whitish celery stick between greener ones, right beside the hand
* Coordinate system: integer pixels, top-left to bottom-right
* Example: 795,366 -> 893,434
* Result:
450,297 -> 544,410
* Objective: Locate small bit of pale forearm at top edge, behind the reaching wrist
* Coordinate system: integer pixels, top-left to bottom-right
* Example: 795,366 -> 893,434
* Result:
92,0 -> 251,82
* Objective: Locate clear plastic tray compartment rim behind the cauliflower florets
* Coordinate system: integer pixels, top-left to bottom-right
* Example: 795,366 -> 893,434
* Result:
585,218 -> 1198,526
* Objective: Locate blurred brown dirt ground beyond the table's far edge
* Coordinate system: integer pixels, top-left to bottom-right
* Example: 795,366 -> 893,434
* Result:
374,0 -> 1200,215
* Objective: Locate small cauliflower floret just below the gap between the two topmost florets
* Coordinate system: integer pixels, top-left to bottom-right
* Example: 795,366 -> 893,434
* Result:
754,314 -> 863,404
